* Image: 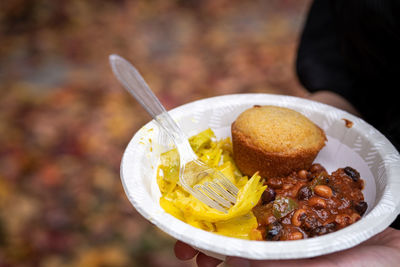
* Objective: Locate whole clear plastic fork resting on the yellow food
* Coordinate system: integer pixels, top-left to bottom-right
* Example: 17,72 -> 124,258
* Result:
110,55 -> 239,213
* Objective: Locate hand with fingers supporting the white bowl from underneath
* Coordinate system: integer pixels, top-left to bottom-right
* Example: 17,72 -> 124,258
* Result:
175,228 -> 400,267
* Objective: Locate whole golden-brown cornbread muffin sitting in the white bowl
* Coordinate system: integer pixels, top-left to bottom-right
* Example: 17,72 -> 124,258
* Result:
231,106 -> 326,178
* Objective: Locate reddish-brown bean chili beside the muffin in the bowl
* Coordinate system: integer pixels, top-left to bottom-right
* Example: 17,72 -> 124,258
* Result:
253,164 -> 368,241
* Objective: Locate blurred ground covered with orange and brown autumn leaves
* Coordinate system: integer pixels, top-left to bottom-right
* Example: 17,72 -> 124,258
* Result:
0,0 -> 310,267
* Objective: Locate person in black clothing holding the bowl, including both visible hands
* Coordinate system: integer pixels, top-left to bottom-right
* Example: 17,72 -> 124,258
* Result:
175,0 -> 400,267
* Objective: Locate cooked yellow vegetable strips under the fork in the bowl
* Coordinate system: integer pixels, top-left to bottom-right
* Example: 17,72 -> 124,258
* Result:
157,129 -> 266,239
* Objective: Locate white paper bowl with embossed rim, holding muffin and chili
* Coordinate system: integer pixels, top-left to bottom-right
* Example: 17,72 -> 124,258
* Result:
121,94 -> 400,259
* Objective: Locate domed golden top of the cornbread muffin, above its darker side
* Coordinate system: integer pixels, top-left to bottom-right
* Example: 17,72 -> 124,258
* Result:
232,106 -> 326,154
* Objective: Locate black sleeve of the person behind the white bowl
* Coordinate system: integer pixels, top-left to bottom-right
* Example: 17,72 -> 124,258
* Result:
296,0 -> 400,124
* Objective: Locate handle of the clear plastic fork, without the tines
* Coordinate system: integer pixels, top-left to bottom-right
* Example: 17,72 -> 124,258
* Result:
110,55 -> 197,162
